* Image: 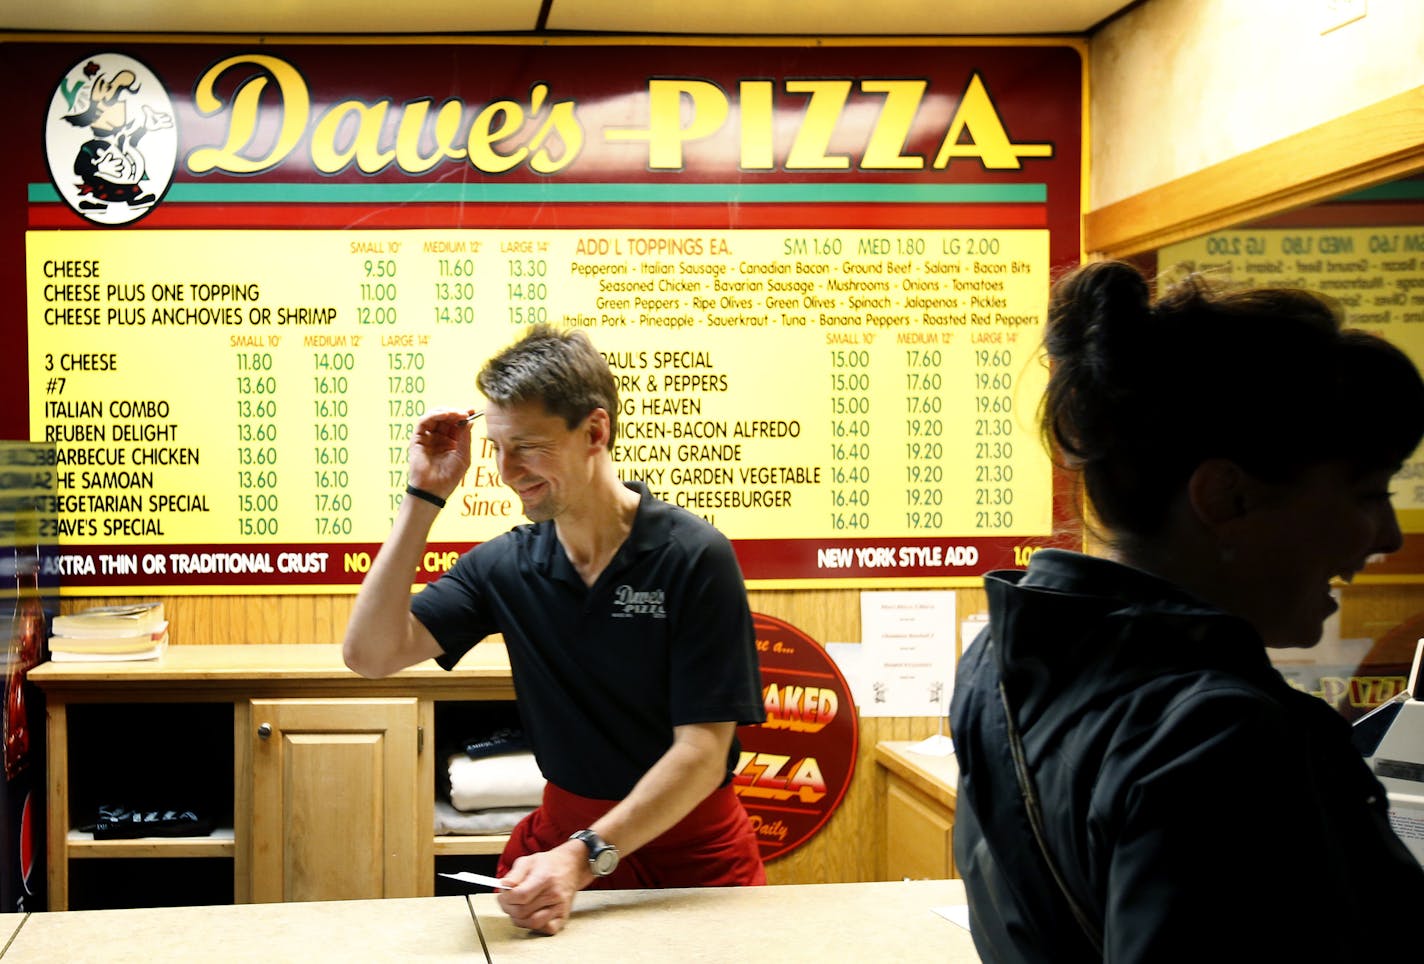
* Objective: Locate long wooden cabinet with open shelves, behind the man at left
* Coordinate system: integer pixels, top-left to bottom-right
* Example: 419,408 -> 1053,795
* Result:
31,642 -> 514,910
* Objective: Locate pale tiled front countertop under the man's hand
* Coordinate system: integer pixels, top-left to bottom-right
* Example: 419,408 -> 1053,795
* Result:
3,880 -> 978,964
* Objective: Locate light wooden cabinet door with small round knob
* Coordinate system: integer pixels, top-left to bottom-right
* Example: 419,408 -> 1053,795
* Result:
249,699 -> 418,903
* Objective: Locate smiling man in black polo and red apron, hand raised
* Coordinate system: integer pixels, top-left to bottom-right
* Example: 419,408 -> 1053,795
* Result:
343,325 -> 766,933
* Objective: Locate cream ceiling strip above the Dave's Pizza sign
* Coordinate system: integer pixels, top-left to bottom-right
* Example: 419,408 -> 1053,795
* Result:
0,0 -> 1135,37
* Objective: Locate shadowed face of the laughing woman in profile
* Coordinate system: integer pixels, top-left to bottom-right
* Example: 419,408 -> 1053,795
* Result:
1229,463 -> 1403,646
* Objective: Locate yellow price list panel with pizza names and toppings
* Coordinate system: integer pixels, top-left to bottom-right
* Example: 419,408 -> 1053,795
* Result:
27,229 -> 1052,565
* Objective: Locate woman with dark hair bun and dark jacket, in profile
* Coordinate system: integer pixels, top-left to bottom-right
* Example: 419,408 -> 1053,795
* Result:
950,262 -> 1424,963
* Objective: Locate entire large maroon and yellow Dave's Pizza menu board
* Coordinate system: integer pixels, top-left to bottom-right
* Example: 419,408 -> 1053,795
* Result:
0,38 -> 1084,586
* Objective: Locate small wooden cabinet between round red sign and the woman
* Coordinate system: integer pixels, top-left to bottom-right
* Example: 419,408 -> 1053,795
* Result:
876,742 -> 960,880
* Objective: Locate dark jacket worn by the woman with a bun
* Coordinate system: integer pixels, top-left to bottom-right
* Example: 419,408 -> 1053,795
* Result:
950,550 -> 1424,964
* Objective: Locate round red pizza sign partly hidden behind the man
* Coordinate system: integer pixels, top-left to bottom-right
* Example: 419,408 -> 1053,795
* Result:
732,612 -> 860,860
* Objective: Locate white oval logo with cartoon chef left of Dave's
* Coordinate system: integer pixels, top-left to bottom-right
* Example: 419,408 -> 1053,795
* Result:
44,53 -> 178,225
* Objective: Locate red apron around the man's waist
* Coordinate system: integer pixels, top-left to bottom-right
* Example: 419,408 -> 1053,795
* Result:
498,783 -> 766,890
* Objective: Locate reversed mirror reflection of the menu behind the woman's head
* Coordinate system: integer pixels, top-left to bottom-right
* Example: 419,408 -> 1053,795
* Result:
1158,225 -> 1424,575
